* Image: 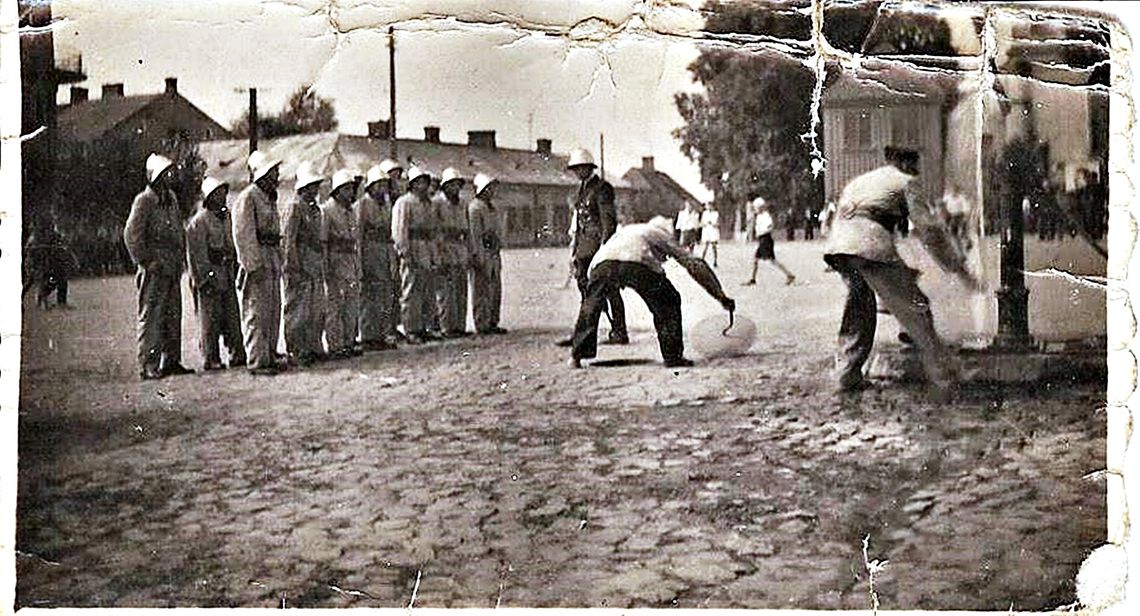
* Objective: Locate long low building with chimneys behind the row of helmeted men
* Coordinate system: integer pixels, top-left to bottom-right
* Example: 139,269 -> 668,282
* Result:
198,128 -> 635,246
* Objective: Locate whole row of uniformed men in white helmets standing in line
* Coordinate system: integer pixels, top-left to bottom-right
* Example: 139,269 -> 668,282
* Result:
123,152 -> 505,379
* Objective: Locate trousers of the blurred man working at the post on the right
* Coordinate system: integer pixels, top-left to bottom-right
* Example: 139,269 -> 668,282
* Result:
824,254 -> 954,387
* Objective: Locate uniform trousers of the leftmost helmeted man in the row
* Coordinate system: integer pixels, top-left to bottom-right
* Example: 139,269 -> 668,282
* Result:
135,265 -> 182,372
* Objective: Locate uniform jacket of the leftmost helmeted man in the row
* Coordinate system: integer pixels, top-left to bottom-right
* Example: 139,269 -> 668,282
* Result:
123,185 -> 186,271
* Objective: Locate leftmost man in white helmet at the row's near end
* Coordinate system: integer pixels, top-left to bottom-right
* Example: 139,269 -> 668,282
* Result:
123,154 -> 194,380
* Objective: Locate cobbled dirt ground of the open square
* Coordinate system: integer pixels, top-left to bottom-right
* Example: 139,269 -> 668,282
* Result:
17,242 -> 1106,610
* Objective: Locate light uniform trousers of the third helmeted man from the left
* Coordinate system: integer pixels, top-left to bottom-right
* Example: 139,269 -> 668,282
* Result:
237,249 -> 282,370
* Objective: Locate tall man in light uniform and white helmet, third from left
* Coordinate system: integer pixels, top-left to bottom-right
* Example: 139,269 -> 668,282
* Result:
233,151 -> 284,376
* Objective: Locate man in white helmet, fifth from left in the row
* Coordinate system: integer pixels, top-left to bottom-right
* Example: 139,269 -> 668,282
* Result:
320,170 -> 360,359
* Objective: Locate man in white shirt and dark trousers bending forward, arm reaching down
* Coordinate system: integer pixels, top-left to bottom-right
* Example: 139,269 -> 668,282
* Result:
570,217 -> 736,368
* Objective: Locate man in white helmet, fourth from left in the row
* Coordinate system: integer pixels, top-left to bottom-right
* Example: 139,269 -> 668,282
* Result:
280,161 -> 326,366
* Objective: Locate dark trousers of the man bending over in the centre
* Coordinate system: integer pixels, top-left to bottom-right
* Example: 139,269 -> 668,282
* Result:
573,261 -> 685,362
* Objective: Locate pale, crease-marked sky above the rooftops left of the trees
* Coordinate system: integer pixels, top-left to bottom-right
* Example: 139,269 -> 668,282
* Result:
54,0 -> 711,198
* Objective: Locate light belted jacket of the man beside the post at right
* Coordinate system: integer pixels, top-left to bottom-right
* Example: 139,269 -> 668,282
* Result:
825,165 -> 919,262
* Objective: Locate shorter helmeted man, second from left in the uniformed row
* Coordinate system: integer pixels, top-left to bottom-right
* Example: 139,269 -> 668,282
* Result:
186,177 -> 245,371
